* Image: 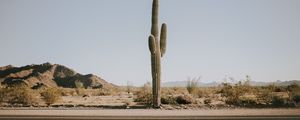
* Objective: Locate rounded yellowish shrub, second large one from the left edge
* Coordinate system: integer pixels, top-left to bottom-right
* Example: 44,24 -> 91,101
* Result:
41,88 -> 62,105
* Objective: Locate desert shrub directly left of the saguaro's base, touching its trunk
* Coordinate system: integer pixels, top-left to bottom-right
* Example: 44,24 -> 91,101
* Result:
134,82 -> 152,105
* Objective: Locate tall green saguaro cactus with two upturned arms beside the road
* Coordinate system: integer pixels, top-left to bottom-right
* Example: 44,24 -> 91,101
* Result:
149,0 -> 167,107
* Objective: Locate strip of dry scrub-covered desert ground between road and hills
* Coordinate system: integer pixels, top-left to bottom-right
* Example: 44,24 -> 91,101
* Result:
0,72 -> 300,109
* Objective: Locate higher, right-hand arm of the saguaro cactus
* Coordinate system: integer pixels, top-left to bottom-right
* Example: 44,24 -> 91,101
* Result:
160,23 -> 167,57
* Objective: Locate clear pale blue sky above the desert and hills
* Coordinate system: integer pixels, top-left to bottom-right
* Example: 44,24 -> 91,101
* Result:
0,0 -> 300,85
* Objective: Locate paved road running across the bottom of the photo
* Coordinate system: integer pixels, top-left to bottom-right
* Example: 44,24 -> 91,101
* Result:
0,109 -> 300,120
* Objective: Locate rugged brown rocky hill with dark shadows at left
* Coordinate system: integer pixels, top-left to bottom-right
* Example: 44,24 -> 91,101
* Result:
0,63 -> 116,88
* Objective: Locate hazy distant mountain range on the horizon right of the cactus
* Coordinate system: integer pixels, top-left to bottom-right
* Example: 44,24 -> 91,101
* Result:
162,80 -> 300,87
